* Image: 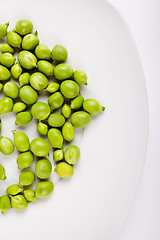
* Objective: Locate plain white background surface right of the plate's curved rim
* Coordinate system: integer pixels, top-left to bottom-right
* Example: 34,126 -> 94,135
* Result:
113,0 -> 160,240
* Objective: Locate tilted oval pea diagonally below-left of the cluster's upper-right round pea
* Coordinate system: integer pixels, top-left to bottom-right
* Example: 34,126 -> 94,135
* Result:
37,60 -> 54,77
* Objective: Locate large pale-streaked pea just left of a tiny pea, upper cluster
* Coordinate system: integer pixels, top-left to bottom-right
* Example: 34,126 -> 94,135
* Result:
30,72 -> 48,90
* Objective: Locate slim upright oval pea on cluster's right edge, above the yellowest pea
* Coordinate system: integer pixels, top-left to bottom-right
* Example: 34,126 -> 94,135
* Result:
62,122 -> 75,142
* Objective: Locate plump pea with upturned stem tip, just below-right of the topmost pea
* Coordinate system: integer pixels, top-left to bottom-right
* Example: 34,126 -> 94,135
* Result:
22,31 -> 39,51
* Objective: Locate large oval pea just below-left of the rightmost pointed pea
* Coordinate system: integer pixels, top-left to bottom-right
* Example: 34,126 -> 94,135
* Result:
71,111 -> 91,128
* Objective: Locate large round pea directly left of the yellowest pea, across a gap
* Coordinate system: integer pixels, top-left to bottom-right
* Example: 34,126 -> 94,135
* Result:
35,159 -> 52,179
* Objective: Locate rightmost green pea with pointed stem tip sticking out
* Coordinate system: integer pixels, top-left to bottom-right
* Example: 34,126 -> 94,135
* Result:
83,98 -> 105,115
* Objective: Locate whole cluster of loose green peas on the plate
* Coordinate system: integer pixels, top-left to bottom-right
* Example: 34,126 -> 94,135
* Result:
0,19 -> 105,213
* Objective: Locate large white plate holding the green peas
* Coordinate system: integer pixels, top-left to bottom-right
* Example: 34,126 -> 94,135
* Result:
0,0 -> 148,240
